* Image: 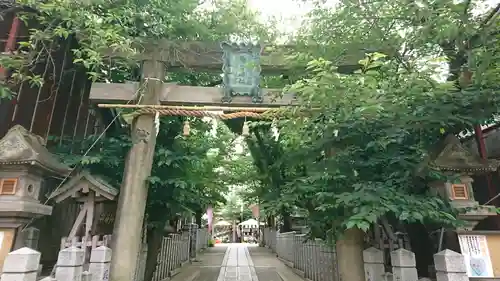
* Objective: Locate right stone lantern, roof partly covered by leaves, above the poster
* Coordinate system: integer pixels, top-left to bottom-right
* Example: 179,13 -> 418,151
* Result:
427,134 -> 500,231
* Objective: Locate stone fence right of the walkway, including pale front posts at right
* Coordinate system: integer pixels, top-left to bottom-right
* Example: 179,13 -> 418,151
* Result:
264,229 -> 469,281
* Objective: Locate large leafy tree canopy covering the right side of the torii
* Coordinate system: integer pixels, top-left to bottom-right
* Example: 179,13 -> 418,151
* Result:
240,0 -> 500,237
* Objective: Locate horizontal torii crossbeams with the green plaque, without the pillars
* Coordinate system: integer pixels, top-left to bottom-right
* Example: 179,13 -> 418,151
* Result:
89,40 -> 364,107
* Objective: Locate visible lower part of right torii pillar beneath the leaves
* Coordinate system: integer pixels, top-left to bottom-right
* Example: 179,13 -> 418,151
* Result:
337,228 -> 364,281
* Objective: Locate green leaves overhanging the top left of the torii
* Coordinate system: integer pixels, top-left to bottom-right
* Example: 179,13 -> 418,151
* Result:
0,0 -> 275,87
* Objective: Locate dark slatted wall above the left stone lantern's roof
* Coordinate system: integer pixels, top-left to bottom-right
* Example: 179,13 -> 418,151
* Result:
0,10 -> 98,139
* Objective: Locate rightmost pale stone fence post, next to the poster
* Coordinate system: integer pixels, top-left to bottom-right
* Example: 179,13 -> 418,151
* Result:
434,250 -> 469,281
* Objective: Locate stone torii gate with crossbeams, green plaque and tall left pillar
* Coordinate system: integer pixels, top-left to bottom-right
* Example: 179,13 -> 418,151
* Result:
89,40 -> 364,281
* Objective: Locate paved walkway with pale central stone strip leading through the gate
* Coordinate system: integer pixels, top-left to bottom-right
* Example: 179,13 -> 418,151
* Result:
172,244 -> 303,281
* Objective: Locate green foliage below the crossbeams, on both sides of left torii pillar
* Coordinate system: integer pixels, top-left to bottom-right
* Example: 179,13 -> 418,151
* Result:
54,117 -> 238,222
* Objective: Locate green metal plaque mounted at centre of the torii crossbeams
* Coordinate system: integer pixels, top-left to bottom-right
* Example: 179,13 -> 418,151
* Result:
221,43 -> 263,103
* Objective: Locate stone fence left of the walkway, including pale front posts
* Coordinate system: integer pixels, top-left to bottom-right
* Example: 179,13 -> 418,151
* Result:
0,229 -> 209,281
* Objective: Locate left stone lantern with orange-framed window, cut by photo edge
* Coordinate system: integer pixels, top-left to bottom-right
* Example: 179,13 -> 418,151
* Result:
0,125 -> 70,266
